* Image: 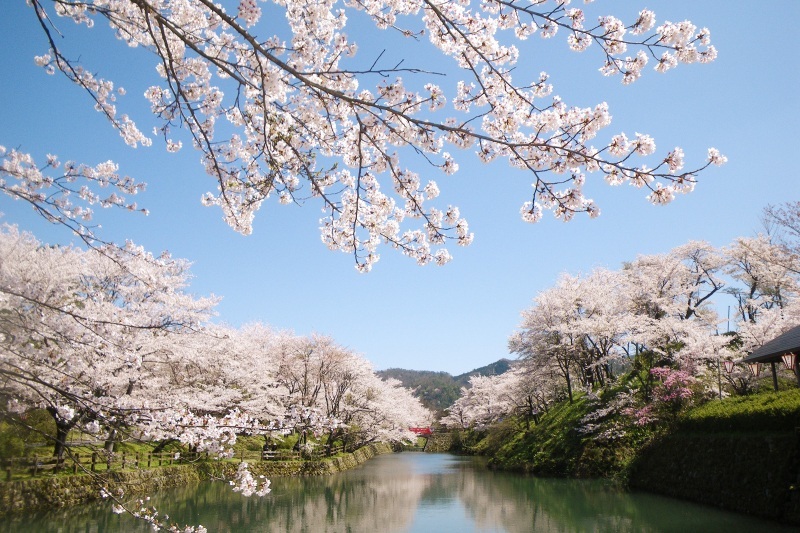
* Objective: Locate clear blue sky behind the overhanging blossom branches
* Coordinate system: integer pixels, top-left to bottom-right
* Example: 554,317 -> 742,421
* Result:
0,0 -> 800,374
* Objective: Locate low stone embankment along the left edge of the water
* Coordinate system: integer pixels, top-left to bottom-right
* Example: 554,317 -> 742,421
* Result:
0,443 -> 392,515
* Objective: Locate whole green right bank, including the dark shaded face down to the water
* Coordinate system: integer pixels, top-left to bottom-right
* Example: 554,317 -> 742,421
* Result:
455,389 -> 800,525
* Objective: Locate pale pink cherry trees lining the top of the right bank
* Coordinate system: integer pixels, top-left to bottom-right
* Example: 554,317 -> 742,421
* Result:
443,230 -> 800,434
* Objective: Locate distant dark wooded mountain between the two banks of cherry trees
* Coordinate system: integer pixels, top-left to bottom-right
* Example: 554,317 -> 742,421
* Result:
376,359 -> 511,412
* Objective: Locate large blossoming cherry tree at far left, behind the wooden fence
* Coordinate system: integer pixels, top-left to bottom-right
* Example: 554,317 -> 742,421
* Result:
0,222 -> 216,457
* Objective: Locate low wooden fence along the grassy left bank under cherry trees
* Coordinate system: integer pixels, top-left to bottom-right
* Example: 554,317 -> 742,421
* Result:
0,446 -> 344,481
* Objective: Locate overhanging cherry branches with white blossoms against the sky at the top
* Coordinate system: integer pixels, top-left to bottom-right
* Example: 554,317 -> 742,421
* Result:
10,0 -> 725,271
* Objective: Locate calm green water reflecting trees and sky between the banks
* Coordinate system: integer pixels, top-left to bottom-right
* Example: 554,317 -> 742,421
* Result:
0,453 -> 796,533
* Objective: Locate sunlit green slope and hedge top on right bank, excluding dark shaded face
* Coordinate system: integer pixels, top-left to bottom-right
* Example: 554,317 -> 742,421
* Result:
482,389 -> 800,480
